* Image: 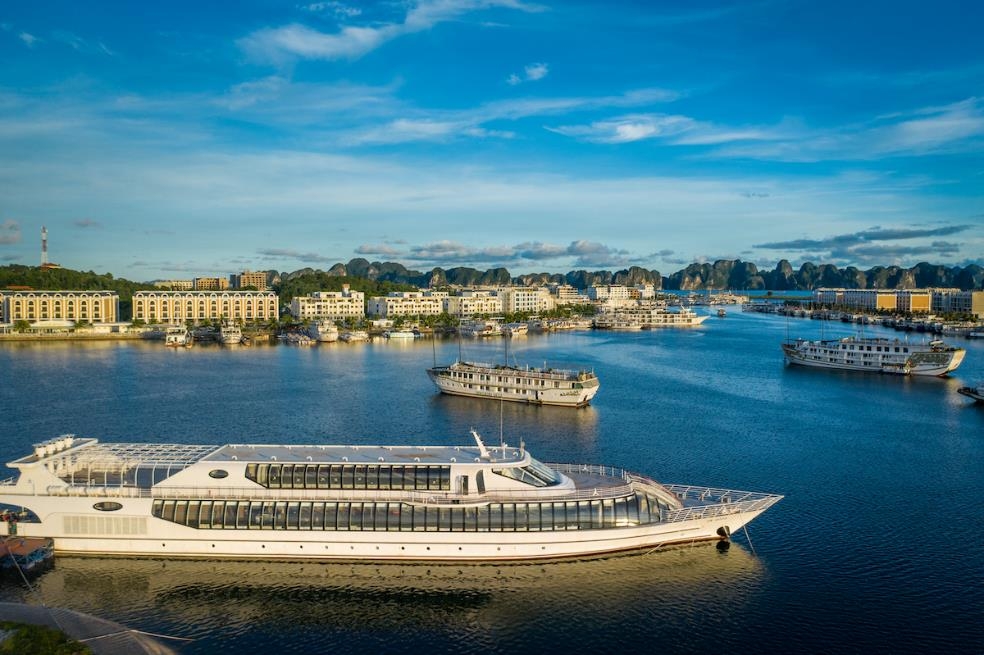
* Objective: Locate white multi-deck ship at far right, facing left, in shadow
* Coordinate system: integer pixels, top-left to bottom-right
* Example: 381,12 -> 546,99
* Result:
782,337 -> 966,376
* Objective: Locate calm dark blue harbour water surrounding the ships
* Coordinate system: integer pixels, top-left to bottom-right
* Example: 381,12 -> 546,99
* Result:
0,310 -> 984,655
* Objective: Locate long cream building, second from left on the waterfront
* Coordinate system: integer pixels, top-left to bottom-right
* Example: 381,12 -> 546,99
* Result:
133,291 -> 279,324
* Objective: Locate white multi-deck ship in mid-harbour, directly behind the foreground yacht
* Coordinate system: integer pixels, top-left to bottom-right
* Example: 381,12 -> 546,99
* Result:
427,361 -> 601,407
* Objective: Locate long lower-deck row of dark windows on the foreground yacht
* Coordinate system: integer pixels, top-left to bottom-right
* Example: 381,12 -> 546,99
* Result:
153,493 -> 667,532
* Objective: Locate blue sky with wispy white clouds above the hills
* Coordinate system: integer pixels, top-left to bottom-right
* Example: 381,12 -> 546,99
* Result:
0,0 -> 984,280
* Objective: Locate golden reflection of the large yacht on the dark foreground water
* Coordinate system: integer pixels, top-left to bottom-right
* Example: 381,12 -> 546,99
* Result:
17,545 -> 763,652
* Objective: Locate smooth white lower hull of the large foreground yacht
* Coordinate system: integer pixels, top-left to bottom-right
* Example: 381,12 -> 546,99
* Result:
0,497 -> 768,561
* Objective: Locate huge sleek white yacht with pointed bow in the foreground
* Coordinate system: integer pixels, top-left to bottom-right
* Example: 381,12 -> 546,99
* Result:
0,433 -> 781,560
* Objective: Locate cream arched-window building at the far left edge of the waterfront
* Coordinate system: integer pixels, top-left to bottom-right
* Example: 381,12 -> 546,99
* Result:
0,291 -> 120,324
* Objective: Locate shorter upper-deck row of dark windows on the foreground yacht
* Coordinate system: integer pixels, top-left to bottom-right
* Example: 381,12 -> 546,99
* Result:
246,464 -> 451,491
